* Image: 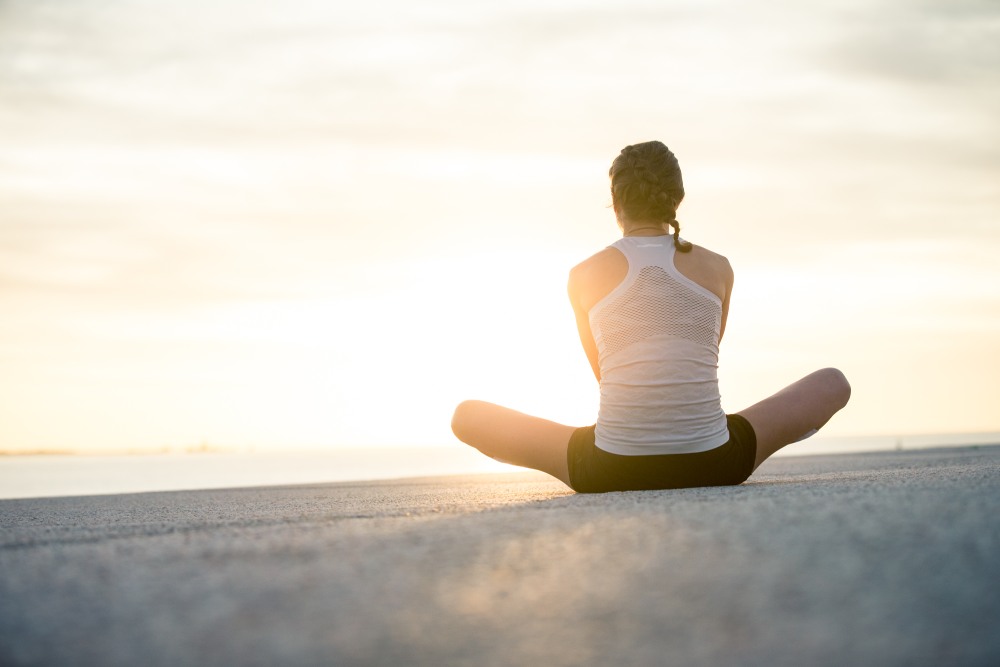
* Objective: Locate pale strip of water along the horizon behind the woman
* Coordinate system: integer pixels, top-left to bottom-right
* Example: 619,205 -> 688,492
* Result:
0,433 -> 1000,498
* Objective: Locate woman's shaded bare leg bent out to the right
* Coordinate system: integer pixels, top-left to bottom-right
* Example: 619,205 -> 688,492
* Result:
737,368 -> 851,470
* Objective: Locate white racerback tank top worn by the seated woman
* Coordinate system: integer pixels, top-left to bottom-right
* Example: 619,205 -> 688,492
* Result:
588,236 -> 729,456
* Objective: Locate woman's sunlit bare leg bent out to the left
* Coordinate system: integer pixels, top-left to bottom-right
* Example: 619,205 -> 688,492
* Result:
451,401 -> 576,486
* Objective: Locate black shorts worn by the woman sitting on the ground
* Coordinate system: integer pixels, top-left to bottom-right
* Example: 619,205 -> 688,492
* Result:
566,415 -> 757,493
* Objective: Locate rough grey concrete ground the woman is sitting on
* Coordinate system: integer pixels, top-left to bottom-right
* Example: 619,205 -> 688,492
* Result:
0,447 -> 1000,667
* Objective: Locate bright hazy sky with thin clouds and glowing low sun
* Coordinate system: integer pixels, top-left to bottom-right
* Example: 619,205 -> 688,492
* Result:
0,0 -> 1000,452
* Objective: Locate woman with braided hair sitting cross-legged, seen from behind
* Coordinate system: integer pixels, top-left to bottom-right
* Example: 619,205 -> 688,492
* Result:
452,141 -> 851,492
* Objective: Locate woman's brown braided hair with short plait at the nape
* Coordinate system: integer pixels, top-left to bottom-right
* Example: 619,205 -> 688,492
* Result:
608,141 -> 691,252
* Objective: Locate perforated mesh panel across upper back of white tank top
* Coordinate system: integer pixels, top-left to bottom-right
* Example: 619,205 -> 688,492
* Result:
596,266 -> 722,354
